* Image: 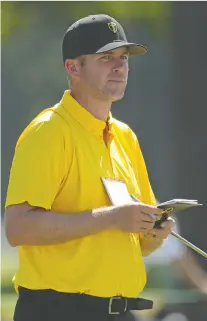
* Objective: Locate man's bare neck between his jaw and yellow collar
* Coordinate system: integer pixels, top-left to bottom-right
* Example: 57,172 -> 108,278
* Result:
70,89 -> 111,122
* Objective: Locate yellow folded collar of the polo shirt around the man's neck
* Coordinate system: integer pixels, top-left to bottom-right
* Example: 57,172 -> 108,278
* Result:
61,90 -> 113,139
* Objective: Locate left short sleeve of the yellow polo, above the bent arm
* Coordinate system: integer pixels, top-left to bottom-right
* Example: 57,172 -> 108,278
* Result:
5,115 -> 66,210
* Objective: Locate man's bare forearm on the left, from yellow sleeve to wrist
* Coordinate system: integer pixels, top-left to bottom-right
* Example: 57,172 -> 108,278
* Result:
6,207 -> 115,246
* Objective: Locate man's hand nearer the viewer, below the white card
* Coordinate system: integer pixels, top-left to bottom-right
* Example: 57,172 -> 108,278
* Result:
112,203 -> 161,233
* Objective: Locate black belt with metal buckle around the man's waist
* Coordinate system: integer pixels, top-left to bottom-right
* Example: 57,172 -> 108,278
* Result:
19,287 -> 153,314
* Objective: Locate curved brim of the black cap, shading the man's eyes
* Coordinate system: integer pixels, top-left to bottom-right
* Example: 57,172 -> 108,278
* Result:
96,41 -> 147,55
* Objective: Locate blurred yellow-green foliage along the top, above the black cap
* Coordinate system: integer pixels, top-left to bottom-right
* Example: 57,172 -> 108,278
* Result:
1,1 -> 171,41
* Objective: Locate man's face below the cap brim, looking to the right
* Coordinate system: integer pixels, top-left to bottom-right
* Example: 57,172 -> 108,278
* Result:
75,48 -> 129,102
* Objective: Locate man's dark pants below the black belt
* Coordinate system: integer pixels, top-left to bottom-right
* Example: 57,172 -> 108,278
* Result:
14,288 -> 139,321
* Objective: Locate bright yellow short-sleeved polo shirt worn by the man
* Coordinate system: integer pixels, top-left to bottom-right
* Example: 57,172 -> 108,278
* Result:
6,91 -> 155,297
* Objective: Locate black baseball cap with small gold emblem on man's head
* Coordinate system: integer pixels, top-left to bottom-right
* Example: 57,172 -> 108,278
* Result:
62,14 -> 147,61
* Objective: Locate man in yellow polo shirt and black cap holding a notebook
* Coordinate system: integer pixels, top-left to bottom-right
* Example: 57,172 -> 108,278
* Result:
6,15 -> 174,321
